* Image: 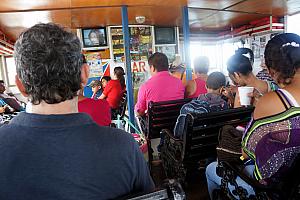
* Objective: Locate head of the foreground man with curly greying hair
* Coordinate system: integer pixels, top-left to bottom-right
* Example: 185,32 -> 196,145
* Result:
14,24 -> 88,105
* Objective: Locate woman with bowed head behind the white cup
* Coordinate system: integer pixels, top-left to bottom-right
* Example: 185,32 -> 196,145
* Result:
227,49 -> 278,108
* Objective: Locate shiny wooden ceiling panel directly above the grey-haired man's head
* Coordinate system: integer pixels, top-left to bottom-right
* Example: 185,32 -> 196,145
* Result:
0,10 -> 71,40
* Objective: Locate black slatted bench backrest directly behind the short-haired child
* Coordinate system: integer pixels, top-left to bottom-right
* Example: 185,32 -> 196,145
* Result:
182,107 -> 254,162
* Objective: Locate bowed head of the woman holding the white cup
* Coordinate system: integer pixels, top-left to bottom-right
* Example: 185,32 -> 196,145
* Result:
227,54 -> 252,86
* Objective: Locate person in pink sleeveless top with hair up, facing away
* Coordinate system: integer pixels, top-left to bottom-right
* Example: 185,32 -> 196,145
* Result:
185,56 -> 209,98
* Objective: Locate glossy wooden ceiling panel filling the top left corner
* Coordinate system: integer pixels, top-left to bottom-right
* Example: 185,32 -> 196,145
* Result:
0,0 -> 71,12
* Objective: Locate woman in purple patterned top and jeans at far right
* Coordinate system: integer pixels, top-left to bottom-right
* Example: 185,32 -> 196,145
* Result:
206,33 -> 300,198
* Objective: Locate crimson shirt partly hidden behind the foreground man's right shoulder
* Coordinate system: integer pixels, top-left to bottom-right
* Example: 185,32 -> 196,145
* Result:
78,98 -> 111,126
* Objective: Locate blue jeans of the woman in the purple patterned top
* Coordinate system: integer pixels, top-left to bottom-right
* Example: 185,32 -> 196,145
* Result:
206,162 -> 255,199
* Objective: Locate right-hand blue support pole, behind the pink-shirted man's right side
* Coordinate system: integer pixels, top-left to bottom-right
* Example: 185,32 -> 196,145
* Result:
182,6 -> 192,81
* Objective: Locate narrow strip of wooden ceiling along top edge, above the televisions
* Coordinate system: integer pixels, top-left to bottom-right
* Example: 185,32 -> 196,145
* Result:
72,0 -> 187,7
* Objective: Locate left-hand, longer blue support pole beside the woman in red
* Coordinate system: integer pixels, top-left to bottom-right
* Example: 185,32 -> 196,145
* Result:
122,5 -> 135,131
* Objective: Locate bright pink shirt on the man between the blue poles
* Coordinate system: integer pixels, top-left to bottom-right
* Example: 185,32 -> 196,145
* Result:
135,71 -> 184,112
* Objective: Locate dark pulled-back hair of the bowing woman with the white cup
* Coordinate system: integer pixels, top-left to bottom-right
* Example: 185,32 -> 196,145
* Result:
227,53 -> 252,76
